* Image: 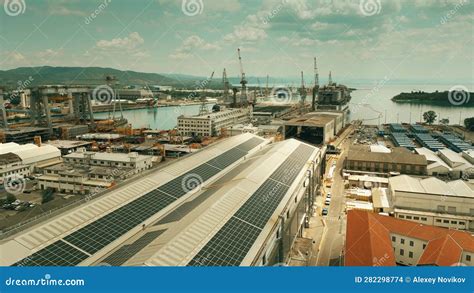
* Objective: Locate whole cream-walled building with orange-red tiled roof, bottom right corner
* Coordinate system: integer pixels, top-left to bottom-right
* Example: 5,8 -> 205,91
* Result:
344,210 -> 474,266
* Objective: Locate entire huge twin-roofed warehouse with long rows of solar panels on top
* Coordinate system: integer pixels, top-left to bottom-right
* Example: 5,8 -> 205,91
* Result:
0,134 -> 322,266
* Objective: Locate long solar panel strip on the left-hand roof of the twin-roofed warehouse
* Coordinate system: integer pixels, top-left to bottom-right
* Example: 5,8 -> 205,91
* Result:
12,137 -> 263,266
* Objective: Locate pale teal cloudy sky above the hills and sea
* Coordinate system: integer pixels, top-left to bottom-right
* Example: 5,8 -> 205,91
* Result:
0,0 -> 474,85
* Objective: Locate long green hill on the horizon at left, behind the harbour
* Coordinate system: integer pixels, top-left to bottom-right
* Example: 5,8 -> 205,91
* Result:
0,66 -> 199,88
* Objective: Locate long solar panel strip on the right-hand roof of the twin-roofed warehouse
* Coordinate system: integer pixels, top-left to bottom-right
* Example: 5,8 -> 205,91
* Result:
188,144 -> 314,266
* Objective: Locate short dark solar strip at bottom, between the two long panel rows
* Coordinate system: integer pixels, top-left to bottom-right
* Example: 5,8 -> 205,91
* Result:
102,230 -> 166,266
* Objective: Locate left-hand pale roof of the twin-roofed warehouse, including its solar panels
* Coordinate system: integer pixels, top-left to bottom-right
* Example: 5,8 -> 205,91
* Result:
0,134 -> 268,266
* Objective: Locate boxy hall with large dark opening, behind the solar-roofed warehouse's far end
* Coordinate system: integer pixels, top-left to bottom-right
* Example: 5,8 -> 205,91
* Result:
284,112 -> 344,145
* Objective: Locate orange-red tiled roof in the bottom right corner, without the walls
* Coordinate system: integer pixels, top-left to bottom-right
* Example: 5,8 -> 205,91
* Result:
345,210 -> 474,266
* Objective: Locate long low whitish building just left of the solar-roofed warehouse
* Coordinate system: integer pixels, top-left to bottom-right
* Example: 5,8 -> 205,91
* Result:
63,148 -> 152,174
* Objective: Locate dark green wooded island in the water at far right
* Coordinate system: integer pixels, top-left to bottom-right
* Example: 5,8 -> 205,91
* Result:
392,91 -> 474,107
